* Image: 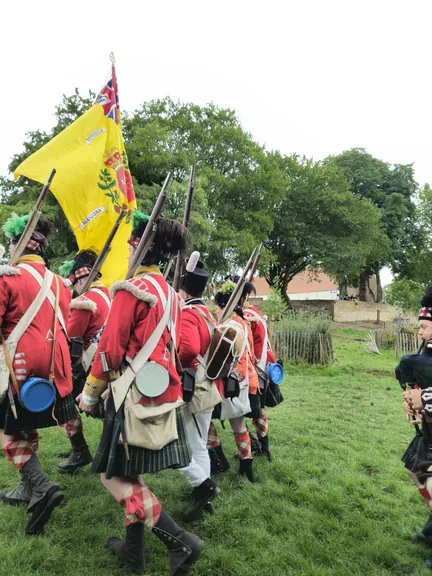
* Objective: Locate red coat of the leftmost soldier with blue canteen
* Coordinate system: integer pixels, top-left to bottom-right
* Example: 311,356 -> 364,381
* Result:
0,256 -> 72,397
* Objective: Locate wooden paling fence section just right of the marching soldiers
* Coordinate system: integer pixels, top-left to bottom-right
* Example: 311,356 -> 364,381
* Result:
273,331 -> 333,364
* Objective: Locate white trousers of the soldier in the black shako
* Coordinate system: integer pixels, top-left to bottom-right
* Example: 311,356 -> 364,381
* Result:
180,408 -> 213,488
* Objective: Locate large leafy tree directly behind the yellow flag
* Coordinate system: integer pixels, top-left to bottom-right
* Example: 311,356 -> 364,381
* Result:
0,91 -> 279,274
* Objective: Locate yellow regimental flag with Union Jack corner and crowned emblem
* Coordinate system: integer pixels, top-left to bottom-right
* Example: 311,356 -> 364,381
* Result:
15,66 -> 136,286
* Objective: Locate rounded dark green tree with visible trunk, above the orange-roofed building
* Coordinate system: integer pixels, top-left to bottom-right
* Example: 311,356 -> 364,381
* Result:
265,154 -> 382,307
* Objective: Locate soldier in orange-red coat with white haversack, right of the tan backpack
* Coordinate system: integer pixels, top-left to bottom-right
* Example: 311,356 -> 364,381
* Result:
207,280 -> 260,483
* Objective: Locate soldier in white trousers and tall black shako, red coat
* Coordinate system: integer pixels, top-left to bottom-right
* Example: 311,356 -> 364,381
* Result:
179,262 -> 221,521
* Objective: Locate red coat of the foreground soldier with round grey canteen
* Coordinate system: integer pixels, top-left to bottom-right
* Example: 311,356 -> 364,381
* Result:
88,266 -> 182,404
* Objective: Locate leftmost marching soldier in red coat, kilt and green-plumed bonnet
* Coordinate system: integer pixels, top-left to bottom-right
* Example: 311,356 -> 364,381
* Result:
0,216 -> 76,534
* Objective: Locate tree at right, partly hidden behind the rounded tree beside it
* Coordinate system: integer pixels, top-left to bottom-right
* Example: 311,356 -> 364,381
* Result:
327,148 -> 418,301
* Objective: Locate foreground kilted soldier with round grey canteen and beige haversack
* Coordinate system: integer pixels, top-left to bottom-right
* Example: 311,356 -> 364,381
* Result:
80,212 -> 203,576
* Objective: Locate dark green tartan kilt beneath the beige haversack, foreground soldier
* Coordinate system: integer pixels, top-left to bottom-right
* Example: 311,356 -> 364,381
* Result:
92,396 -> 191,479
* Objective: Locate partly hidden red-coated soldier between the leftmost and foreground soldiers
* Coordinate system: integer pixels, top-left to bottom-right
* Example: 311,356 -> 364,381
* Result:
57,250 -> 111,474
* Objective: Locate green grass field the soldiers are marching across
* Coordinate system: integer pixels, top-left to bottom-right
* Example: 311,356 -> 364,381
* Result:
0,328 -> 432,576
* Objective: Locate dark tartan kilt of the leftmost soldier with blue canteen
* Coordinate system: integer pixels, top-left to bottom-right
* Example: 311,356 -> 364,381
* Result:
0,392 -> 77,436
